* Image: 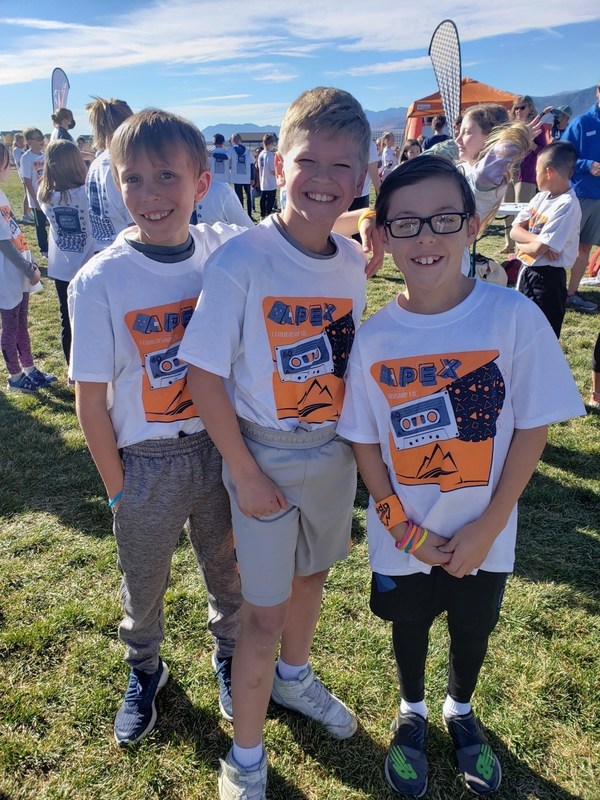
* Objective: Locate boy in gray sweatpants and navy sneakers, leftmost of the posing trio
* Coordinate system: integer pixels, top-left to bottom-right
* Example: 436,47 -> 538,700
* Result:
69,110 -> 247,745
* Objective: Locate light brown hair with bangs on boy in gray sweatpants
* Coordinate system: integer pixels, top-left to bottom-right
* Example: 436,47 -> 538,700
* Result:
110,108 -> 208,183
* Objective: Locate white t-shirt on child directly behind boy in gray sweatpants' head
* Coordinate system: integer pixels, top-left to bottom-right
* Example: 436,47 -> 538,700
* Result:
85,150 -> 133,250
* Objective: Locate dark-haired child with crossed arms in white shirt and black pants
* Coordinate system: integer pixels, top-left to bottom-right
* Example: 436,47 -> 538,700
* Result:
510,140 -> 581,337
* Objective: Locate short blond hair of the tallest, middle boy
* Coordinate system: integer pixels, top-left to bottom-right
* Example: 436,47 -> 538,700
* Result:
279,86 -> 371,168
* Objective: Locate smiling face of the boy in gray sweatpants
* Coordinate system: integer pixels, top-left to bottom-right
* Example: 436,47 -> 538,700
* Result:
116,145 -> 210,246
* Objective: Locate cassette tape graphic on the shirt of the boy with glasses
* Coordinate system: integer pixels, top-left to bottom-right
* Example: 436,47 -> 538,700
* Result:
390,391 -> 458,450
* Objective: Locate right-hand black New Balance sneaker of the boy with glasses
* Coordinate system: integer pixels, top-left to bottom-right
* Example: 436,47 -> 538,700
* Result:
444,711 -> 502,794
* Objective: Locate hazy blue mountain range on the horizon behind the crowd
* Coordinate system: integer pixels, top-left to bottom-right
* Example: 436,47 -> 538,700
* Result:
202,86 -> 596,142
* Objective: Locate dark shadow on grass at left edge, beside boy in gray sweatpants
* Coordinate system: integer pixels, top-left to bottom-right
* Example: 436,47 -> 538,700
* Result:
0,383 -> 111,537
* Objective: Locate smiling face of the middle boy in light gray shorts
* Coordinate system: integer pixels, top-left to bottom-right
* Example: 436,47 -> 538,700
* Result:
275,130 -> 366,253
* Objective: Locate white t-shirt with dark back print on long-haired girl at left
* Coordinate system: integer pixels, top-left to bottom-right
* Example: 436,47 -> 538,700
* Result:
40,186 -> 96,281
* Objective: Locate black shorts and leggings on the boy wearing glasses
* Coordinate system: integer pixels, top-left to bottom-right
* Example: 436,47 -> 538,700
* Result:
371,567 -> 507,703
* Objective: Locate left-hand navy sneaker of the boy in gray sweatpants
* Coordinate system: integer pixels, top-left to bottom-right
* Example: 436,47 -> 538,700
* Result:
115,658 -> 169,747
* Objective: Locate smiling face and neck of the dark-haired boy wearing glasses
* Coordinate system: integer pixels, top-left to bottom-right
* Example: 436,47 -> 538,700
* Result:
384,176 -> 478,313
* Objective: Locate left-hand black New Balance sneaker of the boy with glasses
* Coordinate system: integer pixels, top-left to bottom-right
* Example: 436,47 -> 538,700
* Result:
384,711 -> 427,797
